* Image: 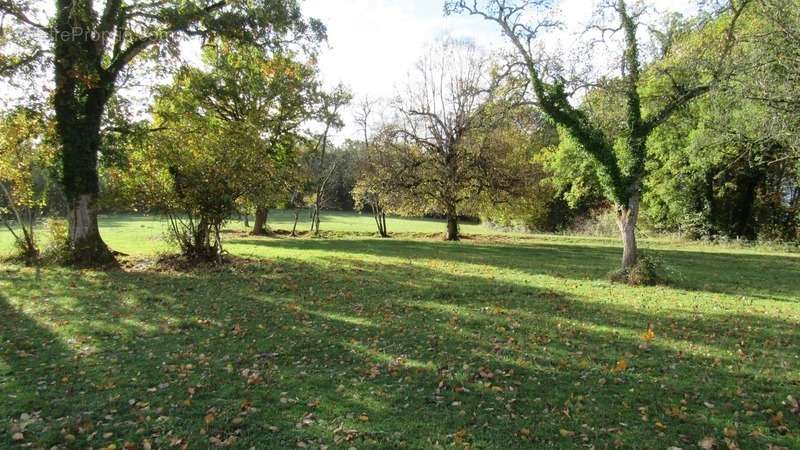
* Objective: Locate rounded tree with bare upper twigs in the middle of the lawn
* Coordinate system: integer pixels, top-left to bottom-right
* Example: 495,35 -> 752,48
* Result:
391,38 -> 503,241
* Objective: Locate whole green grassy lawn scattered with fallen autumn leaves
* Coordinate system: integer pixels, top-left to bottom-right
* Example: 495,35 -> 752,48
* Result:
0,213 -> 800,450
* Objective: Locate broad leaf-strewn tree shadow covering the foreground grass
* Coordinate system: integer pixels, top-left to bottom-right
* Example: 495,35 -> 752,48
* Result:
0,255 -> 800,448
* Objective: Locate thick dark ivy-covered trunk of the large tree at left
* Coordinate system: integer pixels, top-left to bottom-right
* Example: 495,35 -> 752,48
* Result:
54,0 -> 114,266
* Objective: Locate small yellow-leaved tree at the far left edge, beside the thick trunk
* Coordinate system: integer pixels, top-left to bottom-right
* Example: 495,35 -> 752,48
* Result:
0,109 -> 55,264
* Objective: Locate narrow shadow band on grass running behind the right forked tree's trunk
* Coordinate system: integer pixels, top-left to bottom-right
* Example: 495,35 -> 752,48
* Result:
233,239 -> 800,302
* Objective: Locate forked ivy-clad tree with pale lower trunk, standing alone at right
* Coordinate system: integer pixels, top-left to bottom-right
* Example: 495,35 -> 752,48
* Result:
446,0 -> 750,271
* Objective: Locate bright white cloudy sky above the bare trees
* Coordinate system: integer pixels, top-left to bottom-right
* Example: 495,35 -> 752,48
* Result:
303,0 -> 696,139
